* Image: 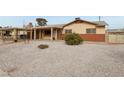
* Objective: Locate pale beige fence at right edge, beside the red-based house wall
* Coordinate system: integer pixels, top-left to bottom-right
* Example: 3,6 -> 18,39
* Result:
109,34 -> 124,43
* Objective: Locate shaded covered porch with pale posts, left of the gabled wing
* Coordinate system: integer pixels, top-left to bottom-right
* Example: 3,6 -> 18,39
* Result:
28,26 -> 62,40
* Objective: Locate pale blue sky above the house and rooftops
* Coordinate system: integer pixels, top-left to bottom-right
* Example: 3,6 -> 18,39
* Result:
0,16 -> 124,28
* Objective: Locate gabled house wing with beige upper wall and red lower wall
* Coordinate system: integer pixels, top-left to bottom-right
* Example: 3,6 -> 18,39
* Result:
62,19 -> 108,41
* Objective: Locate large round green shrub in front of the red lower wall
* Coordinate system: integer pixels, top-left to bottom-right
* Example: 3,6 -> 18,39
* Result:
65,33 -> 83,45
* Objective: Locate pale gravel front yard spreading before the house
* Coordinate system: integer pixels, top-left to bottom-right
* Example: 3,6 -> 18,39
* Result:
0,41 -> 124,77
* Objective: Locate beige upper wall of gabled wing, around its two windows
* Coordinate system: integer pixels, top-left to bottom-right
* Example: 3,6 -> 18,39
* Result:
62,22 -> 105,34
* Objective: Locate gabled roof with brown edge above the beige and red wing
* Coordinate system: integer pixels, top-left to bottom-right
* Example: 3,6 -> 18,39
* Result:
64,18 -> 108,27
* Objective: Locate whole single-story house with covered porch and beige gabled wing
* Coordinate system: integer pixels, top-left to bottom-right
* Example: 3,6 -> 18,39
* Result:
0,18 -> 108,42
